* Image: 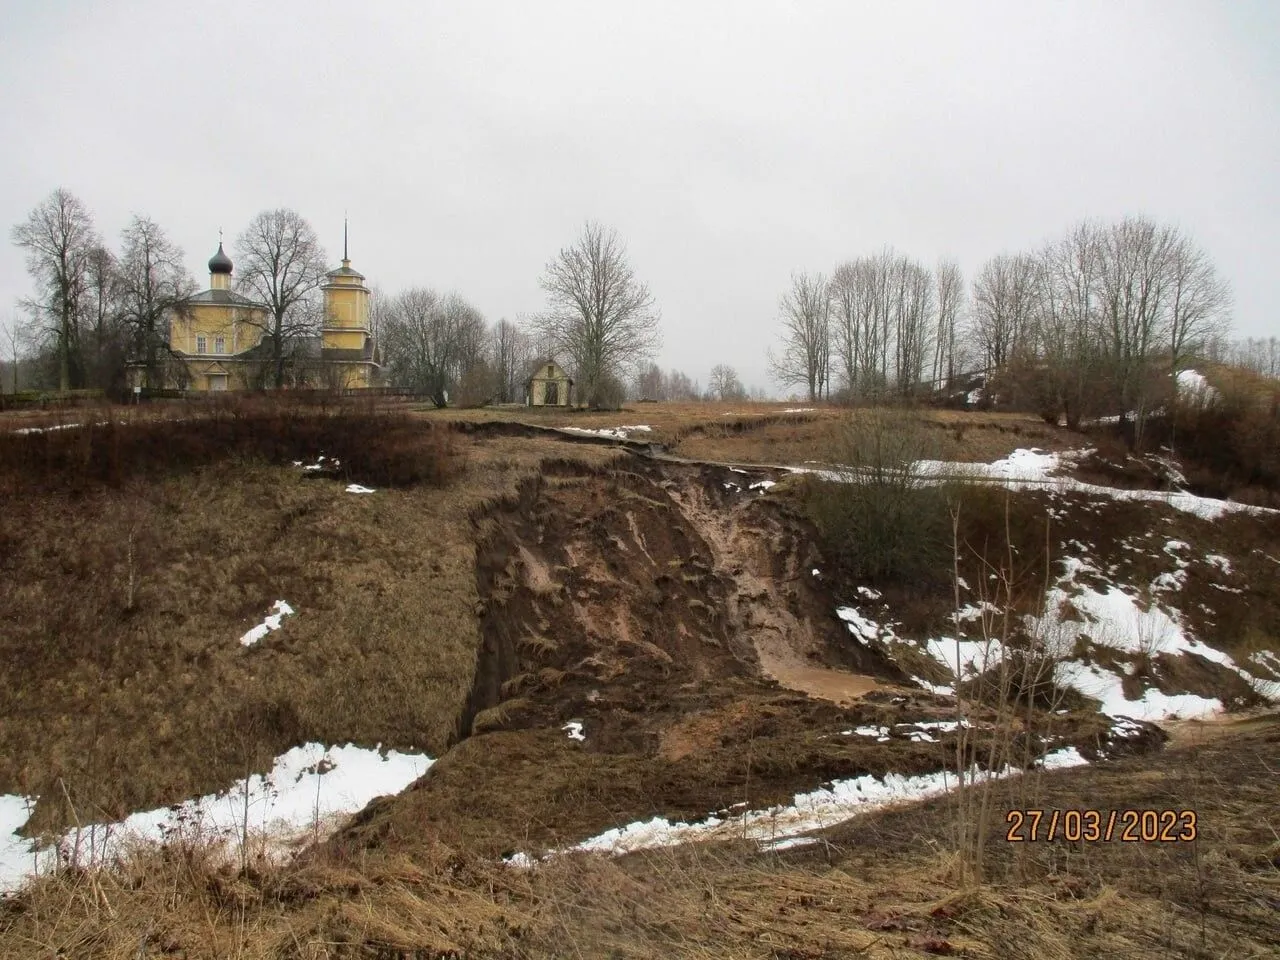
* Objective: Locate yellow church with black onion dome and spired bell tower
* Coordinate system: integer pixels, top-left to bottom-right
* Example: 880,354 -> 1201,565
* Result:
159,225 -> 380,392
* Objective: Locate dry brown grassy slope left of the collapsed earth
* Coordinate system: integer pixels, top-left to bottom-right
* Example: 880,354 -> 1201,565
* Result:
0,425 -> 617,829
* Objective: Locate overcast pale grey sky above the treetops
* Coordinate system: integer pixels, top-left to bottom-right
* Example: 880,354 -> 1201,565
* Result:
0,0 -> 1280,385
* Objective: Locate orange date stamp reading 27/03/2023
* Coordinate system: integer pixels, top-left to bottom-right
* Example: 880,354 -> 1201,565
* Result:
1005,809 -> 1199,844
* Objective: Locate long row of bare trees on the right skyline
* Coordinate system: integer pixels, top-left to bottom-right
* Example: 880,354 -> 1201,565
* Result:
769,218 -> 1230,440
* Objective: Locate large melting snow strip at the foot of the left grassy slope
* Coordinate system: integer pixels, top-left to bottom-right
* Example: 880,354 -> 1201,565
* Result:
0,744 -> 434,890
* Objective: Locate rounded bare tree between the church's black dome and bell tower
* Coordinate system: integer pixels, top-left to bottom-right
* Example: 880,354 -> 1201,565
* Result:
236,209 -> 328,388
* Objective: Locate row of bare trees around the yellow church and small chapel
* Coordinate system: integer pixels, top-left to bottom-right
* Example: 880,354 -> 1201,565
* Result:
6,200 -> 670,406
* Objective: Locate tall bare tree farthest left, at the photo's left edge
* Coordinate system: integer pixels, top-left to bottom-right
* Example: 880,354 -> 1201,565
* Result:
13,187 -> 99,390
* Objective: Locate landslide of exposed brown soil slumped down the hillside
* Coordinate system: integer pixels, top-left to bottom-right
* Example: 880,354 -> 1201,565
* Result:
332,458 -> 1136,856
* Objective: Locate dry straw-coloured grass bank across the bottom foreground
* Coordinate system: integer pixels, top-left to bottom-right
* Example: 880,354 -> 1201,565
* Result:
0,714 -> 1280,960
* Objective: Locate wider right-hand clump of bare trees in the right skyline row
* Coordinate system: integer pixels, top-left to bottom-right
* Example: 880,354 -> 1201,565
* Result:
974,218 -> 1231,443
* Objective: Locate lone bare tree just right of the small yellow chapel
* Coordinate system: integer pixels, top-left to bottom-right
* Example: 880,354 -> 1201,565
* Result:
536,223 -> 662,404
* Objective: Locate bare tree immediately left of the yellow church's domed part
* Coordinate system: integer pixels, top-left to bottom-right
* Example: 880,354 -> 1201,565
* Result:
119,216 -> 195,388
